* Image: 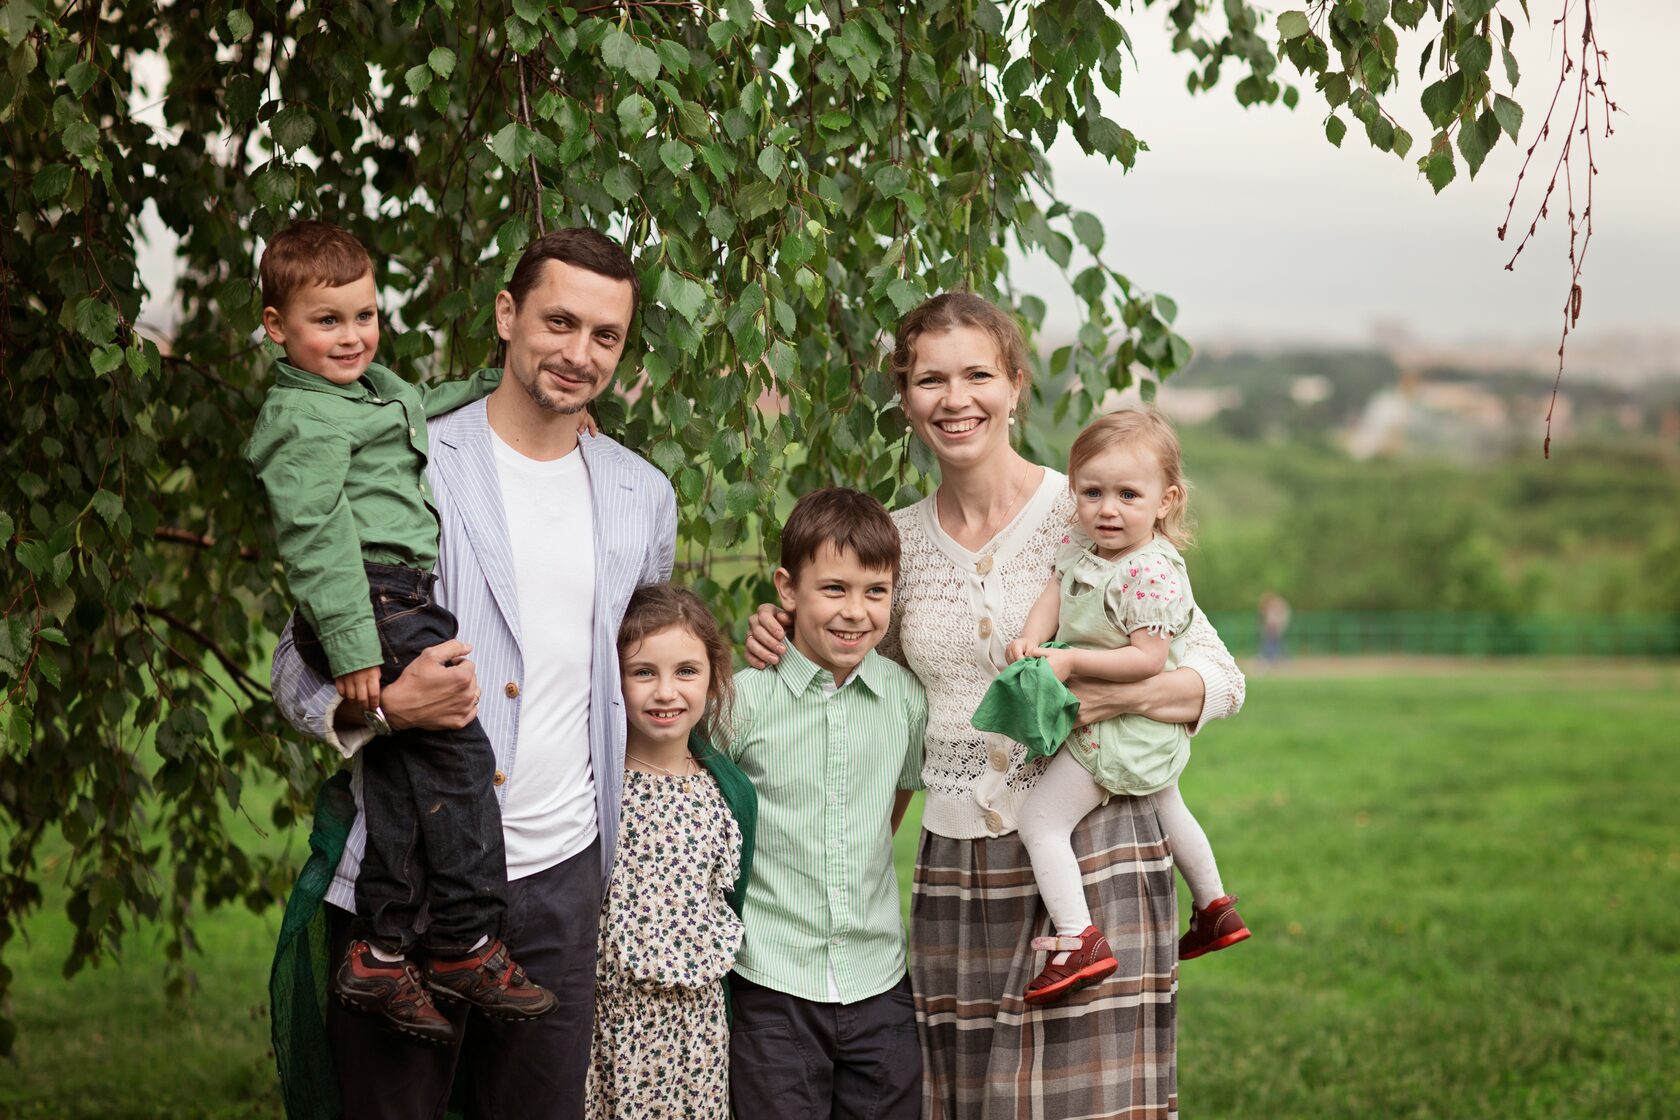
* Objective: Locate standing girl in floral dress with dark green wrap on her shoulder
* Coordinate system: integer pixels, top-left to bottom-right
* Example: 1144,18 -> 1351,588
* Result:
586,584 -> 758,1120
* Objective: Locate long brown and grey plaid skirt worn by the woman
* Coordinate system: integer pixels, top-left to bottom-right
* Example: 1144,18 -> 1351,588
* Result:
911,798 -> 1178,1120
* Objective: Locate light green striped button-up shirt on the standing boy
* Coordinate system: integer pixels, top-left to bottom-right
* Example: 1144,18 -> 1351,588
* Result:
729,643 -> 927,1004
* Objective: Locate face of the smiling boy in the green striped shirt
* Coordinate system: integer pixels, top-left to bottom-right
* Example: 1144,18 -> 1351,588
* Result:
776,541 -> 892,683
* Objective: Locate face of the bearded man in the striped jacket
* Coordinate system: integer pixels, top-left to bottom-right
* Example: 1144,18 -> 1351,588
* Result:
496,260 -> 635,415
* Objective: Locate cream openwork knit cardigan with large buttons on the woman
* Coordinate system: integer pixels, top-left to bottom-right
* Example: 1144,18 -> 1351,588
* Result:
880,468 -> 1245,840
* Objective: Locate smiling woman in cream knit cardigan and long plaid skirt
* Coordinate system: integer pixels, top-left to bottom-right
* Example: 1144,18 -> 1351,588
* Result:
748,294 -> 1243,1120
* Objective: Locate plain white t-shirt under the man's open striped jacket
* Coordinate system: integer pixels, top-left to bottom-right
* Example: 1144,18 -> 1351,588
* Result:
492,433 -> 596,880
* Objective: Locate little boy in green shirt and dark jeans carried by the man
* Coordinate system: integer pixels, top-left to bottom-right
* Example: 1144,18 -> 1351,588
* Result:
245,222 -> 554,1044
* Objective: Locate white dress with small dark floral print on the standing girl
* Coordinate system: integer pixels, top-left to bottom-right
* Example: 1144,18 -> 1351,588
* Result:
585,769 -> 741,1120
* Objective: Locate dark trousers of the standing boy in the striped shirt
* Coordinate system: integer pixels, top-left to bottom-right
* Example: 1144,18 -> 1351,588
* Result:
729,974 -> 922,1120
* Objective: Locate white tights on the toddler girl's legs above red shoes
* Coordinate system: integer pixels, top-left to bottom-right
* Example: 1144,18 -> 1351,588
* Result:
1021,747 -> 1225,937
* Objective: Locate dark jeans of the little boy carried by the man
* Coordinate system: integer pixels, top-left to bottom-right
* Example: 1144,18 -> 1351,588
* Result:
292,564 -> 507,957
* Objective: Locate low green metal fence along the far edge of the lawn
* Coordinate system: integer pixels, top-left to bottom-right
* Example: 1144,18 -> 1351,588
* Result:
1208,611 -> 1680,657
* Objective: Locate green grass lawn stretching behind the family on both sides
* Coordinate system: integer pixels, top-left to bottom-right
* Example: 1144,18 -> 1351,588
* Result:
0,662 -> 1680,1120
